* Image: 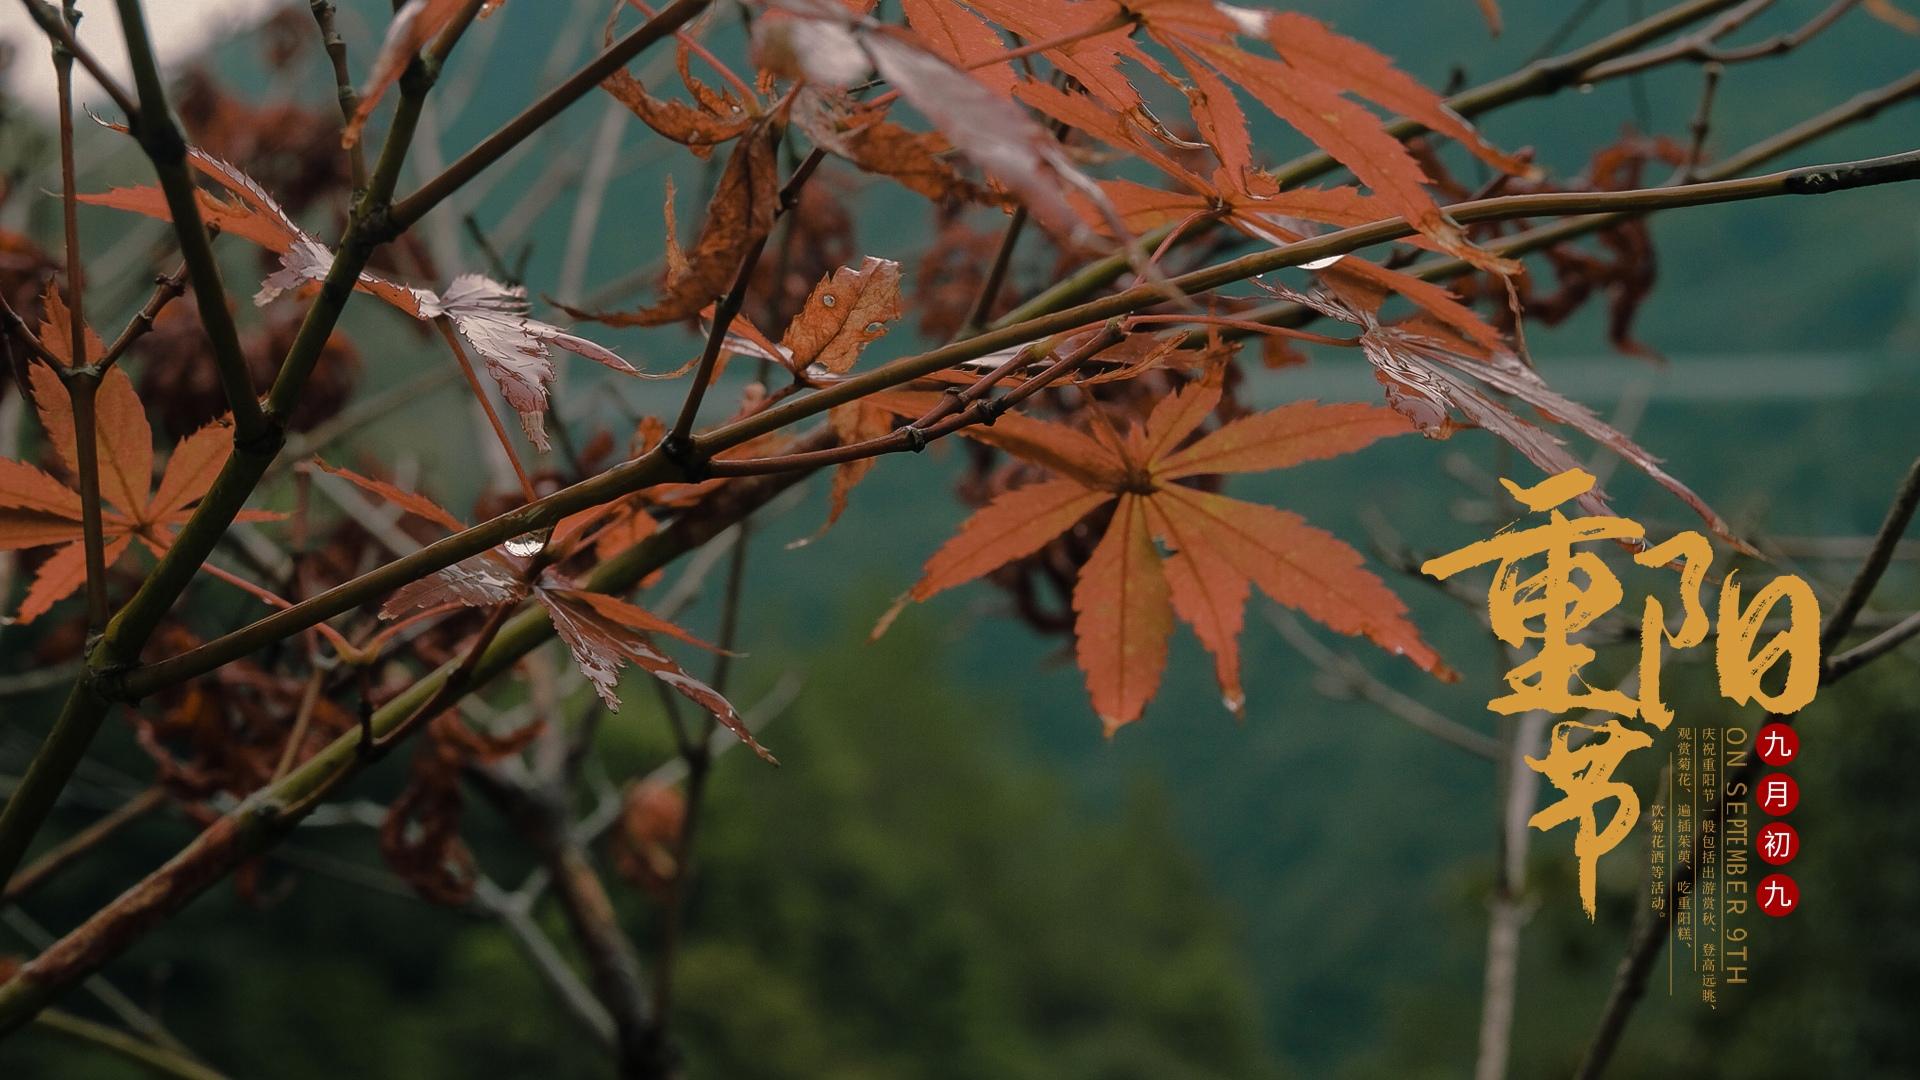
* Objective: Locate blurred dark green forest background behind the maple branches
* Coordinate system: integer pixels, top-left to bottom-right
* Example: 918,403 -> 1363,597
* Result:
0,0 -> 1920,1080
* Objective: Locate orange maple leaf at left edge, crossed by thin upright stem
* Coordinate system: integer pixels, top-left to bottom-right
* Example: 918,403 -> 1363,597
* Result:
0,288 -> 278,623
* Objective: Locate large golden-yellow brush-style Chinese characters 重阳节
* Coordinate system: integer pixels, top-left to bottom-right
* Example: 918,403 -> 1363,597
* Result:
1421,469 -> 1820,919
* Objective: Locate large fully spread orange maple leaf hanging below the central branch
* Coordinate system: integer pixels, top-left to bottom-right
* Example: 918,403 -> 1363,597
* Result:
893,377 -> 1453,734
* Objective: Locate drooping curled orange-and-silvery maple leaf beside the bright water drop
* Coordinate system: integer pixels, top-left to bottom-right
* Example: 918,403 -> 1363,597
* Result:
330,461 -> 774,761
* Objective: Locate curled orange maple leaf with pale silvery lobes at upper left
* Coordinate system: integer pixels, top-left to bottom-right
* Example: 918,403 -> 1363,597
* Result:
77,125 -> 645,452
